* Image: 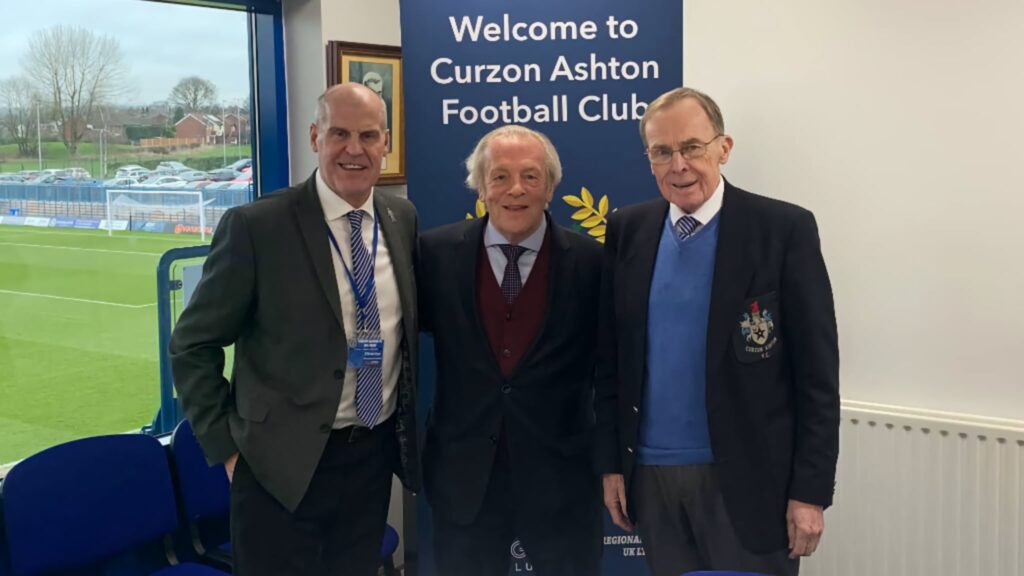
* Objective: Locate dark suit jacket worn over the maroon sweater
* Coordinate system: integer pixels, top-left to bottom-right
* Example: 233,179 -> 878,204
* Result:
418,218 -> 601,524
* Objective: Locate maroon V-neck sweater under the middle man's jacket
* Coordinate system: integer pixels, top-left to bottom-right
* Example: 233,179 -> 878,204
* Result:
476,232 -> 551,378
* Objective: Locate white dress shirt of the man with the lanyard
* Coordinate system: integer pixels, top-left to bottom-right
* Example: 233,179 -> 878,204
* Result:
316,170 -> 403,428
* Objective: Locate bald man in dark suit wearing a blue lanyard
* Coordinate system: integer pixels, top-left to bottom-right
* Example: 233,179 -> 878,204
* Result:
170,84 -> 419,576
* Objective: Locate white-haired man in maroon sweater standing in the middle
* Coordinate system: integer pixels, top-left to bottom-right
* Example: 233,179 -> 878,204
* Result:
419,125 -> 601,576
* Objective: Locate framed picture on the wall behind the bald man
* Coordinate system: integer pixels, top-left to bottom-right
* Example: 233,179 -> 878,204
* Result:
327,40 -> 406,186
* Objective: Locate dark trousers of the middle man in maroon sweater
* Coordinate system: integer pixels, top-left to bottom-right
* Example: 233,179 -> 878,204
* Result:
433,441 -> 598,576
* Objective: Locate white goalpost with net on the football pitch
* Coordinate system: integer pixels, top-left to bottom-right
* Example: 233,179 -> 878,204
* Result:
105,189 -> 207,242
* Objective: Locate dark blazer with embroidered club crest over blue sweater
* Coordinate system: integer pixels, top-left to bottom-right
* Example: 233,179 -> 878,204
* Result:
597,182 -> 840,552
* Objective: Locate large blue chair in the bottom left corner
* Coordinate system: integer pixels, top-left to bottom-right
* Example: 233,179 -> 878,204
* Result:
0,435 -> 223,576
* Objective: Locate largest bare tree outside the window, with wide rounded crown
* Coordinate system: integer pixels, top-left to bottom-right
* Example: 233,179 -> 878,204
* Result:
24,26 -> 125,156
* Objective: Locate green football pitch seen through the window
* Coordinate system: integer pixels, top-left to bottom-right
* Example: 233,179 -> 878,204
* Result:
0,225 -> 207,465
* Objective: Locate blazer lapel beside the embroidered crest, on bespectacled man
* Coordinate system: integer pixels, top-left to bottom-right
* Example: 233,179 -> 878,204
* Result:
708,181 -> 756,385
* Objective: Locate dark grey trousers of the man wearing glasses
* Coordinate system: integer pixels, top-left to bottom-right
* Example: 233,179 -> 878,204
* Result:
631,464 -> 800,576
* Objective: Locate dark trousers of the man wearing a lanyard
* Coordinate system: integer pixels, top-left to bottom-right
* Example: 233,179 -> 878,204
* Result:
231,418 -> 398,576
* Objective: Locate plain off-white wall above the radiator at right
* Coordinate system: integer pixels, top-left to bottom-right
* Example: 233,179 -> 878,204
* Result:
683,0 -> 1024,420
